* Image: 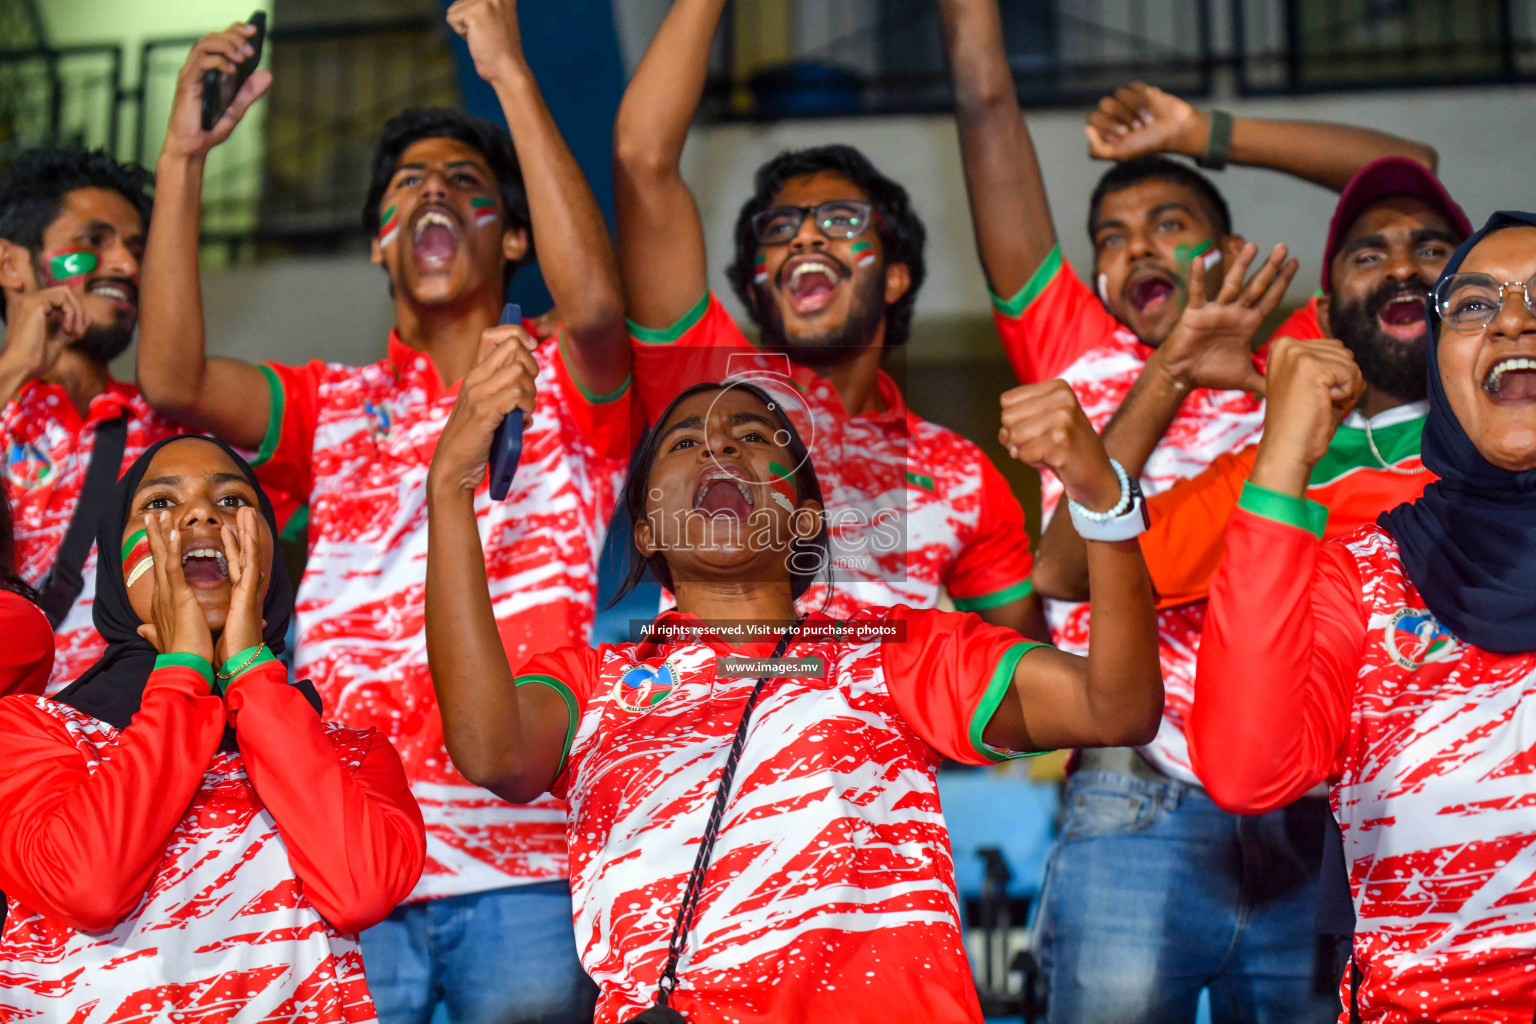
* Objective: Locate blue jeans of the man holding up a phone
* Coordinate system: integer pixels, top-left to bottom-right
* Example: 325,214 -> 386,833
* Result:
362,881 -> 598,1024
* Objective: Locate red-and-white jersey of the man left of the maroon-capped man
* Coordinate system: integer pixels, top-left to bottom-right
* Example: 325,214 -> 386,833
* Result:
994,247 -> 1264,785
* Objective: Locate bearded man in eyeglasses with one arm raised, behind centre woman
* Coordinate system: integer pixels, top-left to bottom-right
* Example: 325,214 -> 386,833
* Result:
614,0 -> 1044,637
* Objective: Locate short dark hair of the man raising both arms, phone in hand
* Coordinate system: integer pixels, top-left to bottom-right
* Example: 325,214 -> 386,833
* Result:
362,106 -> 533,287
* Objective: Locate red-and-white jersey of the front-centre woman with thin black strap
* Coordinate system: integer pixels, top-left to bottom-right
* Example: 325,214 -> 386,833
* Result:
518,606 -> 1038,1024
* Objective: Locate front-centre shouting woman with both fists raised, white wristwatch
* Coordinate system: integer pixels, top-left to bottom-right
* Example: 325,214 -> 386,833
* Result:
427,322 -> 1163,1024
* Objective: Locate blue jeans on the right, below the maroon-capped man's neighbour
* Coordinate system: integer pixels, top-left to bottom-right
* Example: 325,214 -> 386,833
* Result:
1037,771 -> 1339,1024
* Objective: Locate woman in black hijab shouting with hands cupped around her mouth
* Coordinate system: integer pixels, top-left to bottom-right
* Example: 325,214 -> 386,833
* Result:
0,436 -> 425,1024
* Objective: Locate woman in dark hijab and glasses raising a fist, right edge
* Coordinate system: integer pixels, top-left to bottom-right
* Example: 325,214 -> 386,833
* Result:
1190,213 -> 1536,1024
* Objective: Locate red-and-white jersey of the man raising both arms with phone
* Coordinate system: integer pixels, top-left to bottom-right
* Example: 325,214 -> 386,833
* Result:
257,333 -> 631,900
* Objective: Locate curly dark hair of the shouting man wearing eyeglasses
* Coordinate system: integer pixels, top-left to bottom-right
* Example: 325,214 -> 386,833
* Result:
725,146 -> 928,348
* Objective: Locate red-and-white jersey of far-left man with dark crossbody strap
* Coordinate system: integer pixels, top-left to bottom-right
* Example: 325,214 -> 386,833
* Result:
0,381 -> 181,694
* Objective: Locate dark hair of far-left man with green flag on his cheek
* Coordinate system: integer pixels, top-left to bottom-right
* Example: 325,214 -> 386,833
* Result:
0,147 -> 155,321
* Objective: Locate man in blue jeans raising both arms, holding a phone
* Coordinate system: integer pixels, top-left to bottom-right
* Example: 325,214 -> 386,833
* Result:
140,0 -> 630,1024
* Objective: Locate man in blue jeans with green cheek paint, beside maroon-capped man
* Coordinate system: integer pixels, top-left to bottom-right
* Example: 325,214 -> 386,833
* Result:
940,0 -> 1435,1024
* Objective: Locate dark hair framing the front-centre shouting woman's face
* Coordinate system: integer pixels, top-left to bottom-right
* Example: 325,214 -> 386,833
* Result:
608,381 -> 829,608
